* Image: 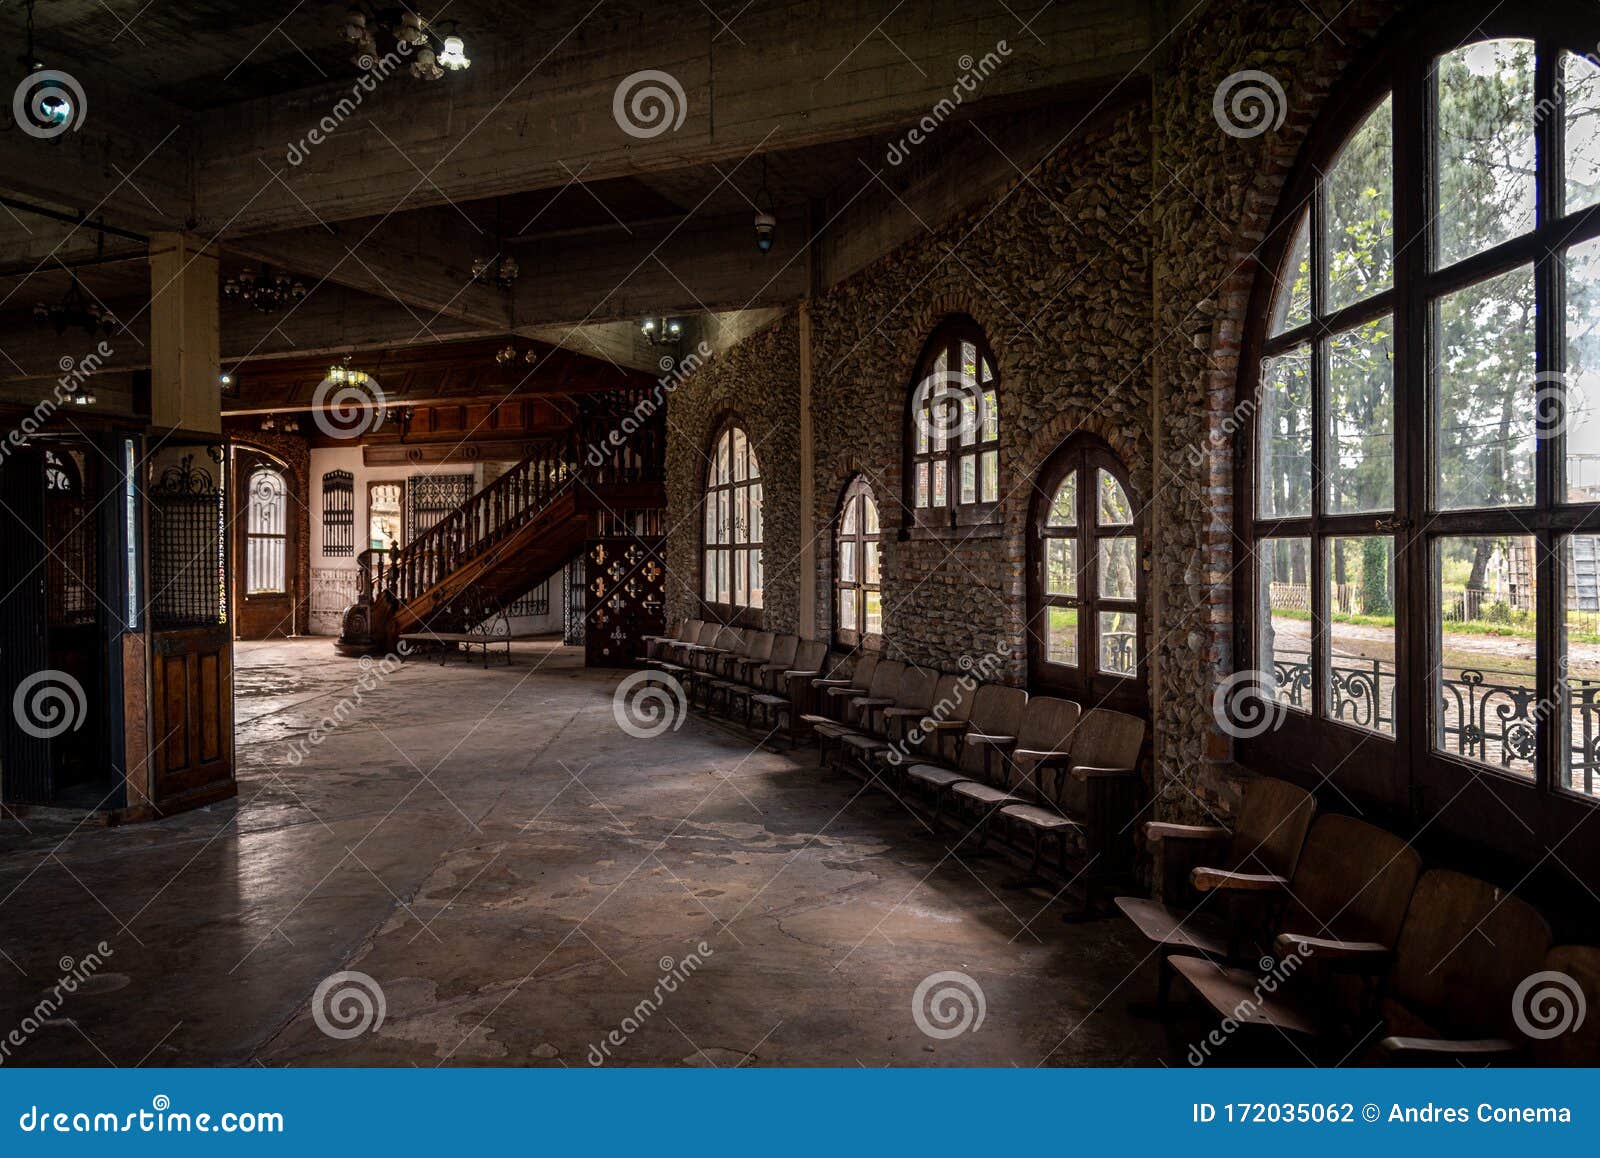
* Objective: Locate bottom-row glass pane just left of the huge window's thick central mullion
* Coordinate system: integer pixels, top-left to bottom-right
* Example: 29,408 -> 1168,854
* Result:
1323,536 -> 1395,734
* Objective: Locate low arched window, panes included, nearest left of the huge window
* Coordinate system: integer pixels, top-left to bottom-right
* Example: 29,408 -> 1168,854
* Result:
1027,435 -> 1144,704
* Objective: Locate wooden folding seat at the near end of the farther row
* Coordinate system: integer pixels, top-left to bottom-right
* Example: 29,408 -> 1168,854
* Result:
995,701 -> 1144,889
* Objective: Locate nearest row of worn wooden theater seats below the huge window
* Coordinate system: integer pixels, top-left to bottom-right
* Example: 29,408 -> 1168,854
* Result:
1117,777 -> 1600,1065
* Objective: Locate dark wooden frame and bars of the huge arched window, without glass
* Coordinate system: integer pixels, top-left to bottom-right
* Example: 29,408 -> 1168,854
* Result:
1234,5 -> 1600,875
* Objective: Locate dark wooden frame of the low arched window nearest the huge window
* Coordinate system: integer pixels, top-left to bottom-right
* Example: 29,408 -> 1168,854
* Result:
1027,435 -> 1149,712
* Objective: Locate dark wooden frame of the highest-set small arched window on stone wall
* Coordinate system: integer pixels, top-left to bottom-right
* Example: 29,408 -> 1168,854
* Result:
904,315 -> 1003,534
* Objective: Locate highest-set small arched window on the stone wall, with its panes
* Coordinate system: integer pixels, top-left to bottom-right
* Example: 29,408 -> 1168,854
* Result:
906,318 -> 1000,528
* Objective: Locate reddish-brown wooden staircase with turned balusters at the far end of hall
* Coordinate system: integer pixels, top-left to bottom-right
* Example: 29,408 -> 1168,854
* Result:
338,395 -> 666,654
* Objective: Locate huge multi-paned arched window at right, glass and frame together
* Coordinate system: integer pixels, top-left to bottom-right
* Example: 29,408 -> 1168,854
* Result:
1235,24 -> 1600,825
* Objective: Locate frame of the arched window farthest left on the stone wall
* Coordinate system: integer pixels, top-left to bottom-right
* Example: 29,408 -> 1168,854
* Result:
699,419 -> 766,627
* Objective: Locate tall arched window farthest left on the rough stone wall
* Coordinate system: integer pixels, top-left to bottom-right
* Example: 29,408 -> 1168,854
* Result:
702,425 -> 762,619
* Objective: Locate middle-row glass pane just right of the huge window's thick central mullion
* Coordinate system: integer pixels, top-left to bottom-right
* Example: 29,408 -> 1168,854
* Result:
1434,266 -> 1534,510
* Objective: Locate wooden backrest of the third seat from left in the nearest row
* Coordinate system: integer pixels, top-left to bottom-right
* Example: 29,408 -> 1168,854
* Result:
1389,869 -> 1550,1041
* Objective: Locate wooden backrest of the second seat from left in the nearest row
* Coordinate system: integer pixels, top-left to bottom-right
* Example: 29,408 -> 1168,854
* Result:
1283,813 -> 1422,948
